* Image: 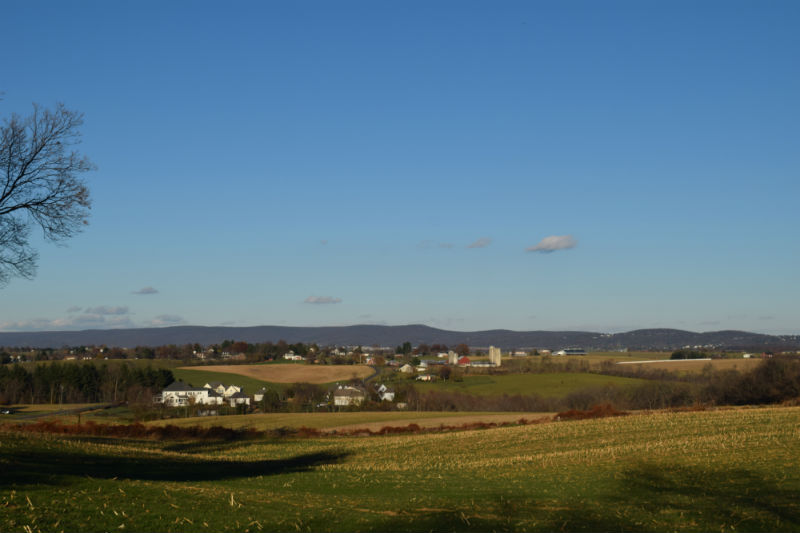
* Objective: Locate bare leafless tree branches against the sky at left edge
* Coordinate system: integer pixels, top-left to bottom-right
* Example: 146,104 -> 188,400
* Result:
0,100 -> 94,286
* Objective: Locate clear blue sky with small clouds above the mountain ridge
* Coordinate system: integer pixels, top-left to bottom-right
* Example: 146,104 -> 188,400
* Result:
0,1 -> 800,333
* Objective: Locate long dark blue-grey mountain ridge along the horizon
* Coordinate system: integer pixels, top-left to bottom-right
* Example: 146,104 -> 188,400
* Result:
0,324 -> 800,350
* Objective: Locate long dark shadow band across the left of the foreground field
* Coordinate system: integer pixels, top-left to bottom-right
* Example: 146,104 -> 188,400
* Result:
0,449 -> 349,487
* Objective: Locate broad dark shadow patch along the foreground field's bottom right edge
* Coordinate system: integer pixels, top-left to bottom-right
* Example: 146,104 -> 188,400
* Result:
366,463 -> 800,532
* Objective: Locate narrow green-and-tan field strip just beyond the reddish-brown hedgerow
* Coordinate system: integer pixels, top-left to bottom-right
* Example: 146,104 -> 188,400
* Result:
147,411 -> 552,430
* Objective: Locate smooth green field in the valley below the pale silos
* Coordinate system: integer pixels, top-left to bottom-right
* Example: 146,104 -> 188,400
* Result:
414,372 -> 647,398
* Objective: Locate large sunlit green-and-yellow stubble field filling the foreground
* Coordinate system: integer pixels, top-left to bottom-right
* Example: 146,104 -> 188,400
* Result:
0,408 -> 800,532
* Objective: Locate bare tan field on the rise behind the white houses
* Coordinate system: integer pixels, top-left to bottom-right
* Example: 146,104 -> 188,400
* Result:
178,363 -> 373,386
